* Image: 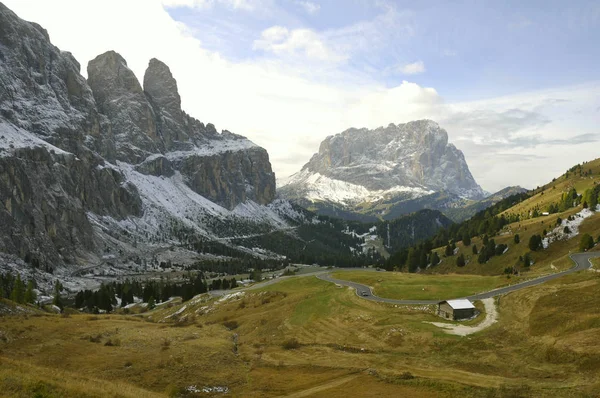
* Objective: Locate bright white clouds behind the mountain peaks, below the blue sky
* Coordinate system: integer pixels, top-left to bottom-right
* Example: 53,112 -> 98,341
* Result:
4,0 -> 600,191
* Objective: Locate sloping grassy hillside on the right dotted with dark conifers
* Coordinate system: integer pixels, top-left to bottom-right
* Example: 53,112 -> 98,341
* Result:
388,159 -> 600,277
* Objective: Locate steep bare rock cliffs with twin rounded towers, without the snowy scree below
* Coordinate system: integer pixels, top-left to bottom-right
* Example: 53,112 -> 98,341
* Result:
0,3 -> 275,264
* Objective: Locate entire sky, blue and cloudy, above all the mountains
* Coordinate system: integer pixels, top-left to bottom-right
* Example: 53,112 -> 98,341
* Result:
3,0 -> 600,192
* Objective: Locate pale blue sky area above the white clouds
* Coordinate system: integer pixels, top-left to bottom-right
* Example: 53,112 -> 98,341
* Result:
168,0 -> 600,100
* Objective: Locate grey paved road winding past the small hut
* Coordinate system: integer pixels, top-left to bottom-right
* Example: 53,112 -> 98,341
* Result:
317,252 -> 600,305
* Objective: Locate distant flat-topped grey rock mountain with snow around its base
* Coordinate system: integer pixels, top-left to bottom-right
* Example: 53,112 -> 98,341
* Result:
278,120 -> 486,219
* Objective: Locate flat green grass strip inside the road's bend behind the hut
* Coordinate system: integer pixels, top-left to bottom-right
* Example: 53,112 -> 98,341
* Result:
333,271 -> 517,300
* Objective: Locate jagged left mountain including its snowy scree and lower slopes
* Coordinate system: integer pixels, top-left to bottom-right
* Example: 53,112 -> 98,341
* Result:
0,3 -> 454,284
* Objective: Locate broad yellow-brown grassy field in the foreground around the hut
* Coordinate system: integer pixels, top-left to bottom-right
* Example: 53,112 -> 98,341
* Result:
0,271 -> 600,397
